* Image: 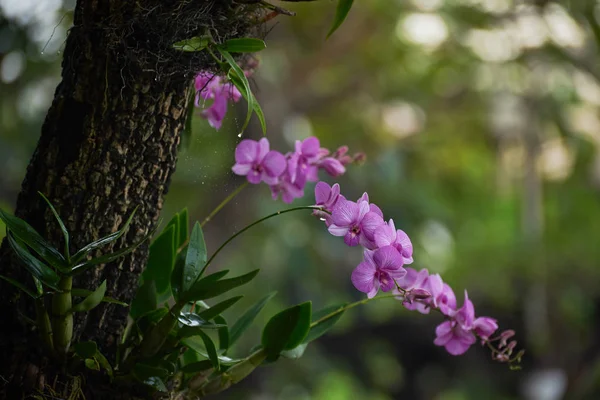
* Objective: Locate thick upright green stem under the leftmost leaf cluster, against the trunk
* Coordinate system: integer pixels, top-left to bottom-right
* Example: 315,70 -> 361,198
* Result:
52,276 -> 73,357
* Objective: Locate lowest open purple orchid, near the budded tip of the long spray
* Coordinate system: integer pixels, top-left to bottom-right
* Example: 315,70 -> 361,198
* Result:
433,291 -> 476,356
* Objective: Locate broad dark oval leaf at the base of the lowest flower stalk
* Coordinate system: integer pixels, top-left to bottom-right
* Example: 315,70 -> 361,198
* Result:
261,301 -> 311,361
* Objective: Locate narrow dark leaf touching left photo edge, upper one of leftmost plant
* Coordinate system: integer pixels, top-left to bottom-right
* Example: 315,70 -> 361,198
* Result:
0,209 -> 69,270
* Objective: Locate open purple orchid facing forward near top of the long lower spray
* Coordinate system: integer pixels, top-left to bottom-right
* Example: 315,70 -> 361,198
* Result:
329,199 -> 383,249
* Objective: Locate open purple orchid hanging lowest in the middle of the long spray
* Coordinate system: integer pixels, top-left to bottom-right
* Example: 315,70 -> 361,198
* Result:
351,246 -> 406,298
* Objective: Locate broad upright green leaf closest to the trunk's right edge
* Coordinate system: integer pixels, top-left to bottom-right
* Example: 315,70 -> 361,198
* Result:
142,226 -> 177,293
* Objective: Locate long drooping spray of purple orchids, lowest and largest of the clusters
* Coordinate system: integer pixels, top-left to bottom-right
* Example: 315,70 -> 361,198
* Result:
315,182 -> 523,364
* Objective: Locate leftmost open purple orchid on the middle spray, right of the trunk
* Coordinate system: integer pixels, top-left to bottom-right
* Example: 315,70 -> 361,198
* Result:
232,138 -> 286,185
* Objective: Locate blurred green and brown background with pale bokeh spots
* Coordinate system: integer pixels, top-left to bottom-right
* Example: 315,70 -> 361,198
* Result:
0,0 -> 600,400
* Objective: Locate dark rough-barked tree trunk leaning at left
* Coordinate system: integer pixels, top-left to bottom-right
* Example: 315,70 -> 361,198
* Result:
0,0 -> 247,399
